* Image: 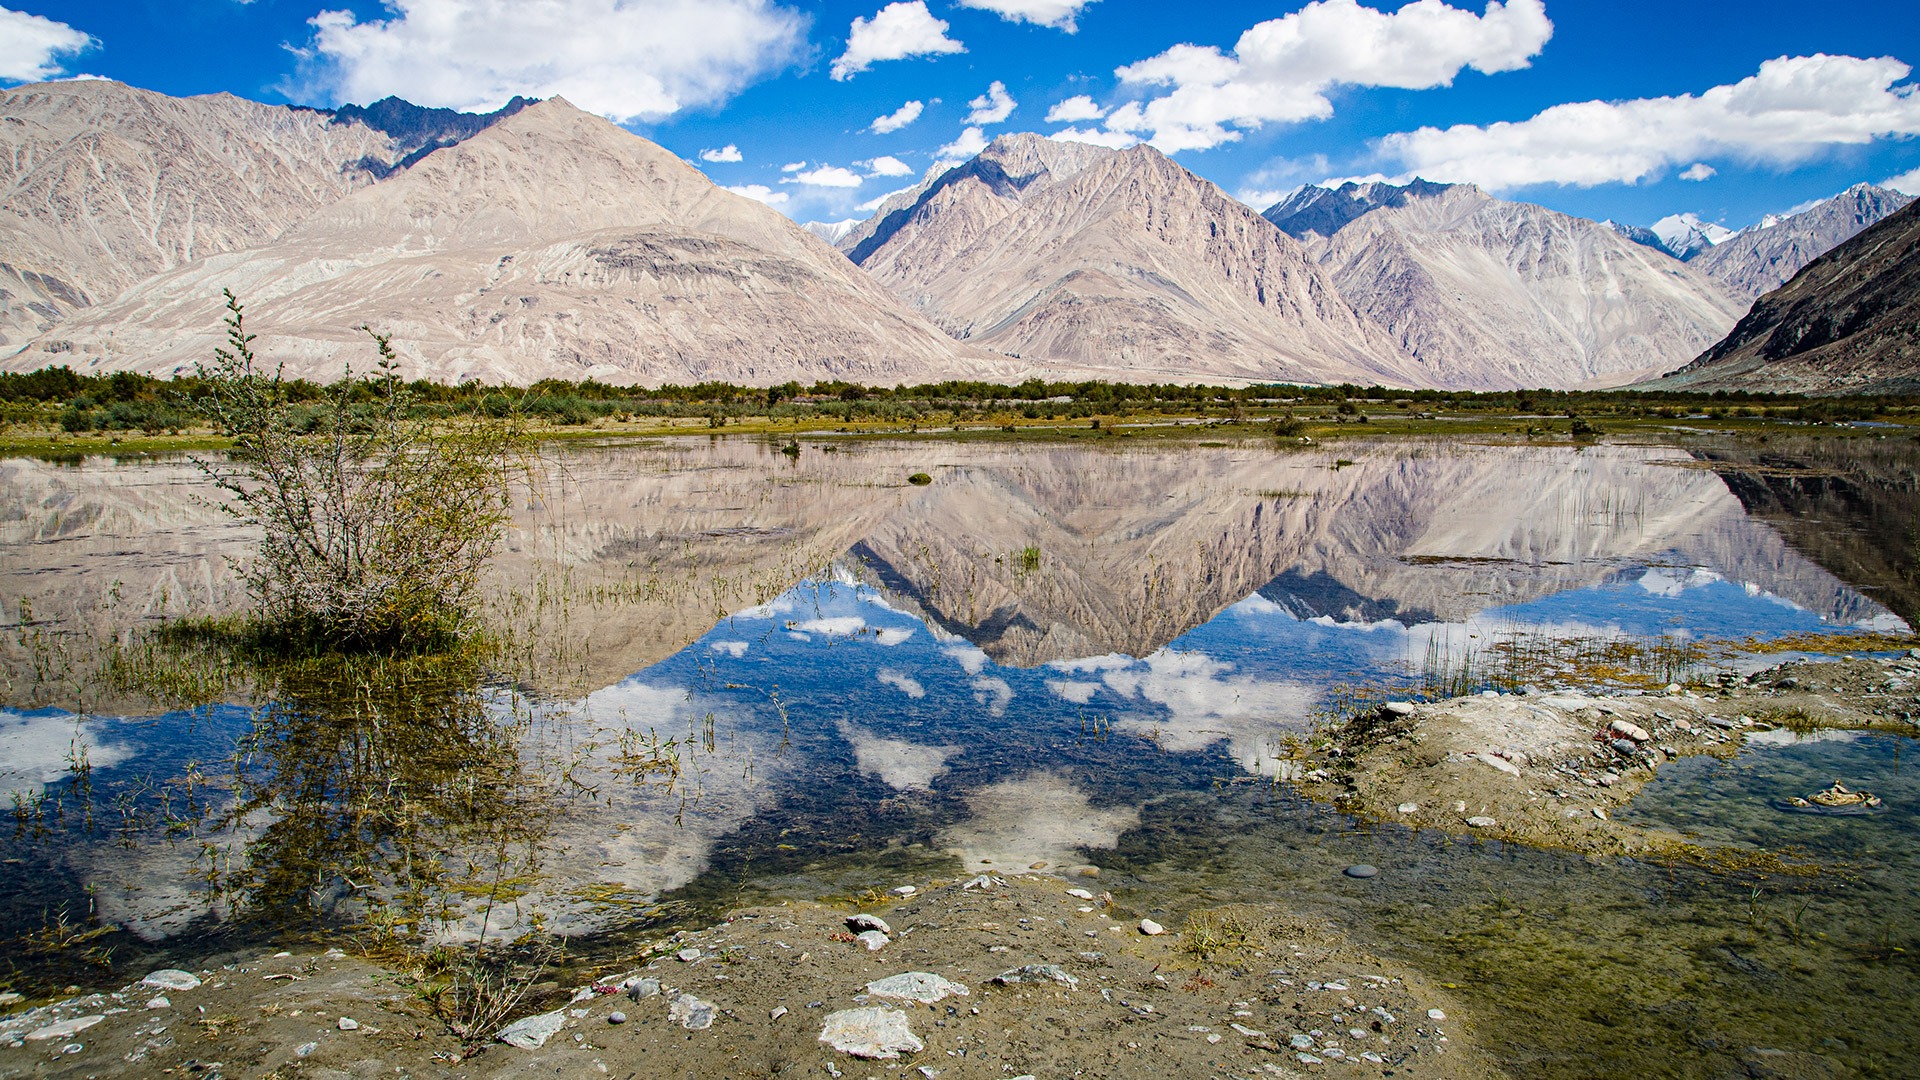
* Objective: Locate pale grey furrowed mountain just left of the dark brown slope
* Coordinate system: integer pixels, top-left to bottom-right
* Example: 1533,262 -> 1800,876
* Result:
1297,184 -> 1740,390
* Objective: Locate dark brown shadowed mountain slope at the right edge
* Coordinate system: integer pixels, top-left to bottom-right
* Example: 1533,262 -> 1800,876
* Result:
1651,202 -> 1920,394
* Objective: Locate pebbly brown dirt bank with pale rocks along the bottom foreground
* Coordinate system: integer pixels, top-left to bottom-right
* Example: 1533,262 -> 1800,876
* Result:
0,874 -> 1498,1080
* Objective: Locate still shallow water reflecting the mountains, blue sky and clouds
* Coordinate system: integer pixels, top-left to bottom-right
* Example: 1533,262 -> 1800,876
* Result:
0,432 -> 1920,1074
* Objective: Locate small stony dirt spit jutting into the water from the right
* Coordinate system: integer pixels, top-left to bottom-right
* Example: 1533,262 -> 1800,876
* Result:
1298,655 -> 1920,855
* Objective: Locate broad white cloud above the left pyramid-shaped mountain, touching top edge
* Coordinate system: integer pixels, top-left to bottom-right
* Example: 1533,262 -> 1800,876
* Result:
303,0 -> 808,123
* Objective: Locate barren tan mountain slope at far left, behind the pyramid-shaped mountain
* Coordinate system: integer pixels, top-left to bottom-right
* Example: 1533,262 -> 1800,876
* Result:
0,79 -> 408,356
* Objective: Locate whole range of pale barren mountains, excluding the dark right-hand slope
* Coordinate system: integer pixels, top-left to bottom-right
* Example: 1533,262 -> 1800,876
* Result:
0,81 -> 1908,390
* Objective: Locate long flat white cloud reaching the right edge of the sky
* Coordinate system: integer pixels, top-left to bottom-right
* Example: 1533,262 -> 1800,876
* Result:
1380,54 -> 1920,190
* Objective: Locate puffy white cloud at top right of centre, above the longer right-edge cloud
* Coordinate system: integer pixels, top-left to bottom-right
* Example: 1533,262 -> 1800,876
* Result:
1106,0 -> 1553,154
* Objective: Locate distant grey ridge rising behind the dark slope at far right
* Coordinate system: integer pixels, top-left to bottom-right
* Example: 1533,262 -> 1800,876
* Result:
1693,184 -> 1912,300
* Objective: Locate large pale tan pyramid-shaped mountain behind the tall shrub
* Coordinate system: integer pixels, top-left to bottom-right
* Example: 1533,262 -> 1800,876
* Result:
6,98 -> 1018,384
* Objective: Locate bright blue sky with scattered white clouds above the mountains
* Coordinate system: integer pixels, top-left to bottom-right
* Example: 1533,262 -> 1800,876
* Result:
0,0 -> 1920,227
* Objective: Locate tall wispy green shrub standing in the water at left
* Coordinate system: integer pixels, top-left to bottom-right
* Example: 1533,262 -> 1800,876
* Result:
196,292 -> 520,650
